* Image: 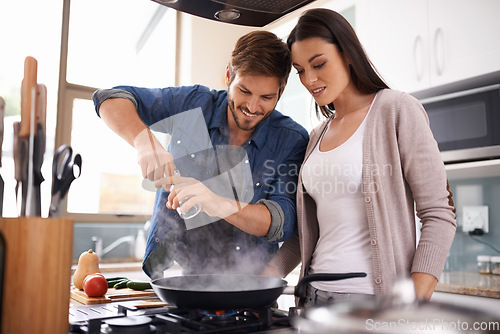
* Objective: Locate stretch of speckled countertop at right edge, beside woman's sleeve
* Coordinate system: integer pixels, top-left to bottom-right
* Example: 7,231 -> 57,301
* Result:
435,271 -> 500,298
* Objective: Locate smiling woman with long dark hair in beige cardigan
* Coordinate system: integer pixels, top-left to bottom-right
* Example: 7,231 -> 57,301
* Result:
263,9 -> 456,304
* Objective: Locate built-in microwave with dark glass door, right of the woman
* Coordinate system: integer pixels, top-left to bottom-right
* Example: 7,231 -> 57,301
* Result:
414,72 -> 500,163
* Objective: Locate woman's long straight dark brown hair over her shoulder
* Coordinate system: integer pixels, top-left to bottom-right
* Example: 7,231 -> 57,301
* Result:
287,8 -> 389,118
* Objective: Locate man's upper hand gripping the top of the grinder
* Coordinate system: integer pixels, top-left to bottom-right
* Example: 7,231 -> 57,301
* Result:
133,128 -> 175,188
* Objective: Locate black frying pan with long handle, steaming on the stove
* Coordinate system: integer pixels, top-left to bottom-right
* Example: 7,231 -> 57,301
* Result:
151,273 -> 366,310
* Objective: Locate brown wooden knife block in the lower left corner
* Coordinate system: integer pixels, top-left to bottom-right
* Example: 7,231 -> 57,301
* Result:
0,217 -> 73,334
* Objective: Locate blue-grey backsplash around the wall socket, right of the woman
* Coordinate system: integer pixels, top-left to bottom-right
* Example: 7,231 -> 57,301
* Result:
445,176 -> 500,272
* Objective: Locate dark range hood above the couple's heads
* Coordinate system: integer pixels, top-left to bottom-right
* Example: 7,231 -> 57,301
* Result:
152,0 -> 314,27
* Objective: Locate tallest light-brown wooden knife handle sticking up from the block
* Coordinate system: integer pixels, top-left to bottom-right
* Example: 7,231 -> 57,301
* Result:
19,56 -> 38,137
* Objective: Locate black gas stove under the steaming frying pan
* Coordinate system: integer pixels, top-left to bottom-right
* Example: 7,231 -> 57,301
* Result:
69,302 -> 296,334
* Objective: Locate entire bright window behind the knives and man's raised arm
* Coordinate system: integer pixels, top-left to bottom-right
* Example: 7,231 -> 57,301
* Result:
0,0 -> 178,222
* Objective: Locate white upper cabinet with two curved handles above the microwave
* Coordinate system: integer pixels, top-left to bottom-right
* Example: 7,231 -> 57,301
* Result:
356,0 -> 500,92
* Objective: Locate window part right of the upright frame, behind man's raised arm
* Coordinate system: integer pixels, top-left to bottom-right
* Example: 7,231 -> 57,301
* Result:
59,0 -> 176,221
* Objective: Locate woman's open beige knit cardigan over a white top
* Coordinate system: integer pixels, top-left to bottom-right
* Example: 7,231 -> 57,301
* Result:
270,89 -> 456,295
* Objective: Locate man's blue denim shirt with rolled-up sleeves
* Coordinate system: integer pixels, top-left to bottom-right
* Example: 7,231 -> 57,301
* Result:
93,85 -> 309,278
